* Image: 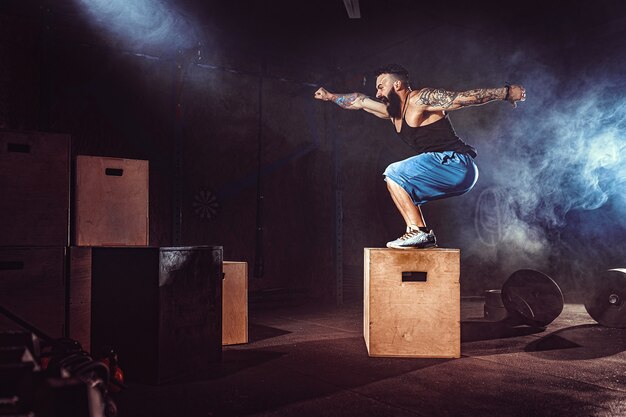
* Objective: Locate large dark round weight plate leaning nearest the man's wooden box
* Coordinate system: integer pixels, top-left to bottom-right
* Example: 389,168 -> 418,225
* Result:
502,269 -> 563,327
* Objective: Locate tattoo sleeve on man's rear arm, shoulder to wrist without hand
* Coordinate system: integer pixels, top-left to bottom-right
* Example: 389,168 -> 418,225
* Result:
417,87 -> 506,109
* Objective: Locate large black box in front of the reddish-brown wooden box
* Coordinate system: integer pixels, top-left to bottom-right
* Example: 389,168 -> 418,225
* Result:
91,246 -> 223,383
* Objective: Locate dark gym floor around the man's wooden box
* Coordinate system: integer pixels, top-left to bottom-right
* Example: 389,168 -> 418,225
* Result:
116,299 -> 626,417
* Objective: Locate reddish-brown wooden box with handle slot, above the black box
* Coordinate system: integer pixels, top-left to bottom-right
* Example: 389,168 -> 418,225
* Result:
74,155 -> 148,246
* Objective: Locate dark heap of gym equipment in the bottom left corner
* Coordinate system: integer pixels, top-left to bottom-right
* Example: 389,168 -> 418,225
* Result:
0,307 -> 117,417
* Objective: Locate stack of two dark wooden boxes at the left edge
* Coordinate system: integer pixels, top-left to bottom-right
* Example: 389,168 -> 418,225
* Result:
0,131 -> 70,337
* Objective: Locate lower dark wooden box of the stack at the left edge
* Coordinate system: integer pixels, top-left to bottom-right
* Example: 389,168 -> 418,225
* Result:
0,247 -> 66,338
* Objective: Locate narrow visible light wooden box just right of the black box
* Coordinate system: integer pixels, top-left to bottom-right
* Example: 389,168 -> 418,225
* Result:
222,261 -> 248,345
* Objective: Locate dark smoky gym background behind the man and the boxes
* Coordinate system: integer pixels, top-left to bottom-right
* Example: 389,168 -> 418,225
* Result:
0,0 -> 626,303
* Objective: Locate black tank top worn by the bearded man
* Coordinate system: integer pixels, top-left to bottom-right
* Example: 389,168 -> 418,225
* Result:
398,114 -> 476,158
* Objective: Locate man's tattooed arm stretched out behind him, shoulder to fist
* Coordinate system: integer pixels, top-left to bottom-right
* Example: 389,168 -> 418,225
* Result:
415,85 -> 526,111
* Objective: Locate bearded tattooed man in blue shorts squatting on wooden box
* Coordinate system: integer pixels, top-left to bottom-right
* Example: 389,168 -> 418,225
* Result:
315,64 -> 526,249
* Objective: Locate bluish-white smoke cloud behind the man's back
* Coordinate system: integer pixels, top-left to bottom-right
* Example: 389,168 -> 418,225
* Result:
464,57 -> 626,265
